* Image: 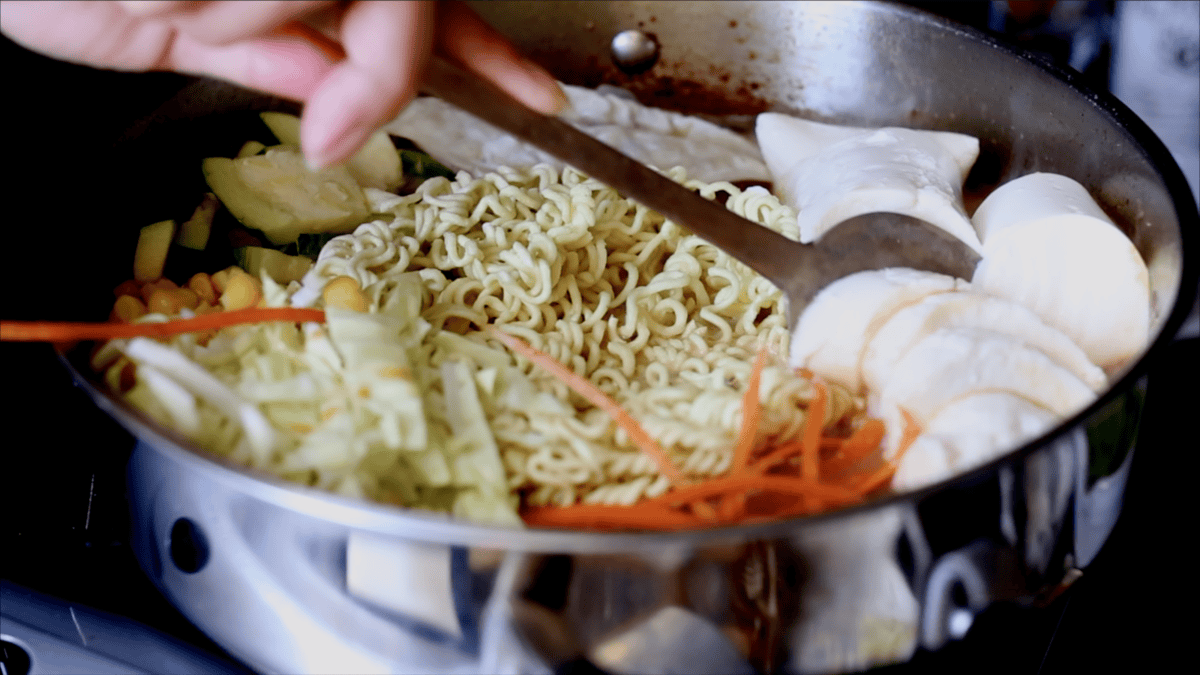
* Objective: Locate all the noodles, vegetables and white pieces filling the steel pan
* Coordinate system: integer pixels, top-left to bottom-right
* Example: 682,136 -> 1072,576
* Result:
2,81 -> 1132,530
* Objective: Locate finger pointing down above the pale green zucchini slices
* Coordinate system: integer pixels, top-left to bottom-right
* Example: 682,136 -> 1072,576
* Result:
300,2 -> 434,167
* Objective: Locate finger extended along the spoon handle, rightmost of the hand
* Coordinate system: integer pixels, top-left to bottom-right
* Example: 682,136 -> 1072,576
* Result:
436,2 -> 566,115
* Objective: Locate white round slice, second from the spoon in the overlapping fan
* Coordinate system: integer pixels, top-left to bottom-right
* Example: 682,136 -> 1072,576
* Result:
862,291 -> 1108,392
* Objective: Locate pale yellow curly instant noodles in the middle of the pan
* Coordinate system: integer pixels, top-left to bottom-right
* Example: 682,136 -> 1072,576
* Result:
306,166 -> 860,506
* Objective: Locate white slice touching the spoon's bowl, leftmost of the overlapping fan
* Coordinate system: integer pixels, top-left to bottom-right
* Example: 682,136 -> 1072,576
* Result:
788,268 -> 966,390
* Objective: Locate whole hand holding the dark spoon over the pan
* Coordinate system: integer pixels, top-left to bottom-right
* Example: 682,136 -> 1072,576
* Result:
0,0 -> 565,167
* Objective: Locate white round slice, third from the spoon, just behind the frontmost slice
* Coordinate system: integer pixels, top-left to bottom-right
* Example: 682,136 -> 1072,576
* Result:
872,328 -> 1094,453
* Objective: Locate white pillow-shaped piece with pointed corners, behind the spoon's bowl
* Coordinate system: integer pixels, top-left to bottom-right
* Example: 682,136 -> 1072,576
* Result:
755,113 -> 980,251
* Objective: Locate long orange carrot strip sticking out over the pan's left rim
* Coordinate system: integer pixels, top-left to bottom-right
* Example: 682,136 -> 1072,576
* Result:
0,307 -> 325,342
